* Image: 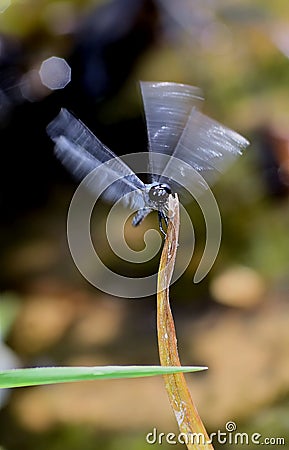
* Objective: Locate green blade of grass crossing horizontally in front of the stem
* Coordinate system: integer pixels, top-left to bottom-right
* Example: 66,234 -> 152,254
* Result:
0,366 -> 206,388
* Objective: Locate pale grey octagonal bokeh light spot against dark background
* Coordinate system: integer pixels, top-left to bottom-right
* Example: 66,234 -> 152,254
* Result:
39,56 -> 71,90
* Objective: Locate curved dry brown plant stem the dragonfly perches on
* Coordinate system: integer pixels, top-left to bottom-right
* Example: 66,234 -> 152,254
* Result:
157,196 -> 213,450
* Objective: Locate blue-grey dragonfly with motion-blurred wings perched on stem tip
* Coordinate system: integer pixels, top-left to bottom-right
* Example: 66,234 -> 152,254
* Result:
47,81 -> 249,235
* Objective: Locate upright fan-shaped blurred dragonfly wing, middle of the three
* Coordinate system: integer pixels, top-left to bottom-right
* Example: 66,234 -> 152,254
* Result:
140,81 -> 203,181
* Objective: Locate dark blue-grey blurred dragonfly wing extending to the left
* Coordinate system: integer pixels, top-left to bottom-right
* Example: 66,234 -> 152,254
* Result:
47,109 -> 145,208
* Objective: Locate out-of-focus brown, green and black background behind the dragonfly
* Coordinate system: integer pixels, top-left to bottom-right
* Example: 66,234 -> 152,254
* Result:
0,0 -> 289,450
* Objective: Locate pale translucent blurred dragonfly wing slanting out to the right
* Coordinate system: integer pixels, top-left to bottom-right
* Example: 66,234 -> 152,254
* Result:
156,109 -> 249,199
